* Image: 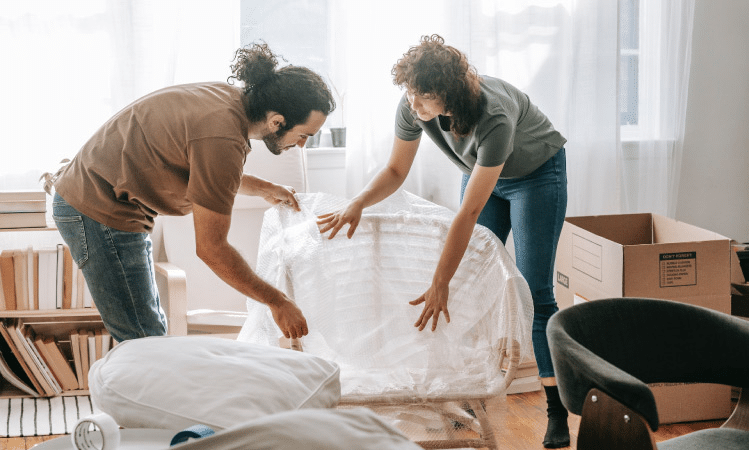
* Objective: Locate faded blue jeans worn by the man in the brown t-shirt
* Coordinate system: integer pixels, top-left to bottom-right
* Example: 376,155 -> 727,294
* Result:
52,194 -> 167,342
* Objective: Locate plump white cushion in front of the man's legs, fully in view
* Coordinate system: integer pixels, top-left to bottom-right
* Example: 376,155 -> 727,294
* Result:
89,336 -> 341,430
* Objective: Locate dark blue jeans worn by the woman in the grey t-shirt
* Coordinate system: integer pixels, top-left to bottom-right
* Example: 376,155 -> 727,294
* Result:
460,148 -> 567,378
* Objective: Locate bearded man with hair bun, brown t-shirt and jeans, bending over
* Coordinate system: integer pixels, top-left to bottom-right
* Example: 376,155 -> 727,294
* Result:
53,44 -> 335,341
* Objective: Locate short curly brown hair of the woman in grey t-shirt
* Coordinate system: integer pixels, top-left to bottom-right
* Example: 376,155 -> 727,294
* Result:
391,34 -> 486,136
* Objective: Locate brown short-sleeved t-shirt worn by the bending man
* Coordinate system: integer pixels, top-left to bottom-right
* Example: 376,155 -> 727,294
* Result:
55,82 -> 250,232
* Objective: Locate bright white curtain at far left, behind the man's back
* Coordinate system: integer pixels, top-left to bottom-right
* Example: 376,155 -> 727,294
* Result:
0,0 -> 239,189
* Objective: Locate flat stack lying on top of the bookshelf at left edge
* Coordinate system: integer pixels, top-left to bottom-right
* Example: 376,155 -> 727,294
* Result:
0,191 -> 47,229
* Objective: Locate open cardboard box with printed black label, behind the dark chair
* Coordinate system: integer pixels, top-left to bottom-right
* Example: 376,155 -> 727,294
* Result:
556,213 -> 732,423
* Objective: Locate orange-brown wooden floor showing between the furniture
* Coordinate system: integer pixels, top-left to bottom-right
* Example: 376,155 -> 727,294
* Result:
0,391 -> 723,450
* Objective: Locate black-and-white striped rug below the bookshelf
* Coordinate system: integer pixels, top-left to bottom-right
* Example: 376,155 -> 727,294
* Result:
0,395 -> 99,437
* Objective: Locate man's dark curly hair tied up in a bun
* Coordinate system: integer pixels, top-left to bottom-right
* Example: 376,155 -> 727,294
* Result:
229,42 -> 336,131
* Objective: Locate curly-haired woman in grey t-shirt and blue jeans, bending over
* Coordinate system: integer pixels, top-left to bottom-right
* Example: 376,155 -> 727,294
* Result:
318,35 -> 570,448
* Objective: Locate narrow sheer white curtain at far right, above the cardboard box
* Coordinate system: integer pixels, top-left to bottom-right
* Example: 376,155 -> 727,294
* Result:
622,0 -> 694,217
